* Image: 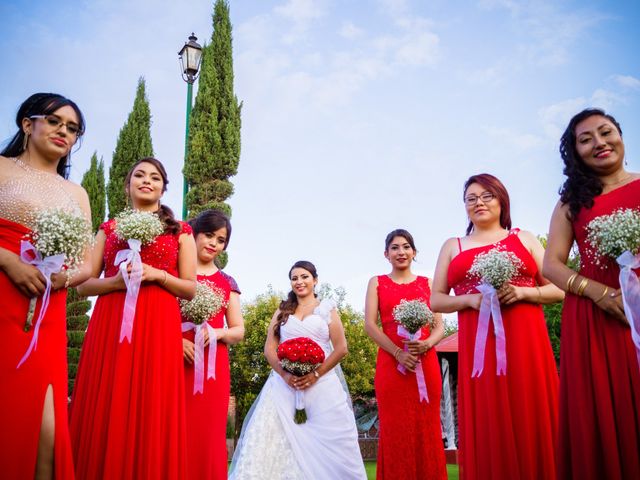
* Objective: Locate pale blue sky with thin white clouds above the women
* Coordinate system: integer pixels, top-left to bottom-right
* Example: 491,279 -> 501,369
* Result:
0,0 -> 640,308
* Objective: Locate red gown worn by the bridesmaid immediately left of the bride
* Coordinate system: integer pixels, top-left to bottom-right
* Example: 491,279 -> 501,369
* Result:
182,271 -> 240,480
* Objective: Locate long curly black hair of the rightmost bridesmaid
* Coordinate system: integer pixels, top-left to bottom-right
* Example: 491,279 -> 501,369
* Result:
559,108 -> 622,219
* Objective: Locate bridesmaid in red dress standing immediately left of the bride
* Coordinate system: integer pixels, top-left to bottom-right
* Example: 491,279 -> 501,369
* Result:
182,210 -> 244,480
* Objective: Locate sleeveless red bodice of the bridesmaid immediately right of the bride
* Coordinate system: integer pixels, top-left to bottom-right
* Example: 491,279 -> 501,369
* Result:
378,275 -> 431,343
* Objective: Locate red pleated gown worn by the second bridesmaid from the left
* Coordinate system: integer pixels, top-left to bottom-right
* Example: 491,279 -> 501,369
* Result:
70,220 -> 191,480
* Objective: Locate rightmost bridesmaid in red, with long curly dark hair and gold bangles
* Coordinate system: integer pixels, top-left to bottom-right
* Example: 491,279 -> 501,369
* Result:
544,109 -> 640,480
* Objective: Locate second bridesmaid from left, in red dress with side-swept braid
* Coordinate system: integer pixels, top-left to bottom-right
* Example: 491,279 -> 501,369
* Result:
70,158 -> 196,480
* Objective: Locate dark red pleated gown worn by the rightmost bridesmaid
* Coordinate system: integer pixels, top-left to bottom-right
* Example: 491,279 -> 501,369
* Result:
558,180 -> 640,480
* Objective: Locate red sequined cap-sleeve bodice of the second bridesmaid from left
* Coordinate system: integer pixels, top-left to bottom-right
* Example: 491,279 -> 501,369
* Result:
100,220 -> 192,277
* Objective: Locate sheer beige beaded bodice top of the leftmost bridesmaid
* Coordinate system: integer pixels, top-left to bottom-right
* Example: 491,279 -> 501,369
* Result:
0,159 -> 82,230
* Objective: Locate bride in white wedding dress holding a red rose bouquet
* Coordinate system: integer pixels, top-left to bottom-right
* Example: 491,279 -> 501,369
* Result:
229,261 -> 367,480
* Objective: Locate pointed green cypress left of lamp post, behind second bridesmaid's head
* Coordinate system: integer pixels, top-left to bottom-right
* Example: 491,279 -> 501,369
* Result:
107,77 -> 153,218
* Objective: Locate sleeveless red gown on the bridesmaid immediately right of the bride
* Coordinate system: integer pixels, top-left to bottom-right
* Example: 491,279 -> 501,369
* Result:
375,275 -> 447,480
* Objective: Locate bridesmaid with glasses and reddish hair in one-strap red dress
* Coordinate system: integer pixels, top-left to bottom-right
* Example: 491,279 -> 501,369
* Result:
431,173 -> 563,480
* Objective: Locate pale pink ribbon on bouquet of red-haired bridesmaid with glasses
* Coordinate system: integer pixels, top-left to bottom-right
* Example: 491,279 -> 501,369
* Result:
471,283 -> 507,377
